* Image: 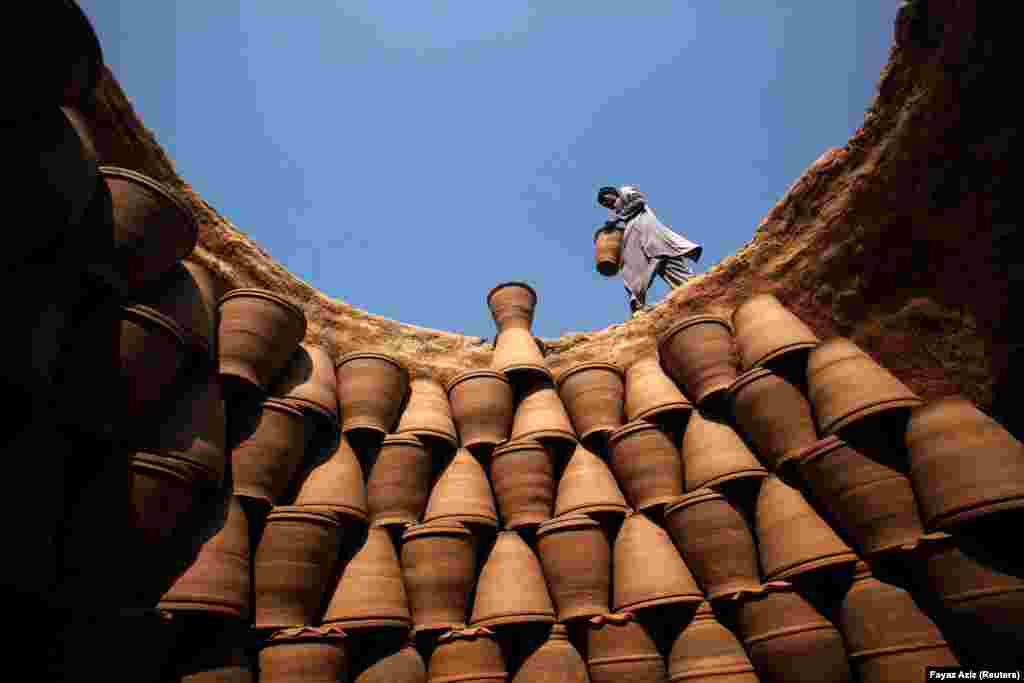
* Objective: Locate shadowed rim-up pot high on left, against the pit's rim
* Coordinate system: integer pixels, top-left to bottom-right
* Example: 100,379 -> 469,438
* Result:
99,166 -> 199,290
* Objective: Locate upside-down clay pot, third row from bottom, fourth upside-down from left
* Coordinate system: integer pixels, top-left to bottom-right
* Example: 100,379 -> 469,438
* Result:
682,411 -> 768,492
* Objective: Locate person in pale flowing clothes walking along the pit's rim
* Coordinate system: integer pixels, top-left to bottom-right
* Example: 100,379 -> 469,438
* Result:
597,185 -> 703,317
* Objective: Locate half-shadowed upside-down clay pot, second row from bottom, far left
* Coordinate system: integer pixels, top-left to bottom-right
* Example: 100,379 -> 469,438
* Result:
158,496 -> 252,618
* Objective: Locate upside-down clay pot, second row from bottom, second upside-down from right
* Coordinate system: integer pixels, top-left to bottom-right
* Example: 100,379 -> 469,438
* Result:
755,475 -> 857,581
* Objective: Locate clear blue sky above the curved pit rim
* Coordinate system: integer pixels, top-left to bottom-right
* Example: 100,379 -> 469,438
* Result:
79,0 -> 898,338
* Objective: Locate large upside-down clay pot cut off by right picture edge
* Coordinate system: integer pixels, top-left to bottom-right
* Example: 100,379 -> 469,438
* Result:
906,396 -> 1024,530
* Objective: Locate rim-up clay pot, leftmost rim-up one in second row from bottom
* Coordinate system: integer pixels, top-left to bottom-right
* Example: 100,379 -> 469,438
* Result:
253,506 -> 342,629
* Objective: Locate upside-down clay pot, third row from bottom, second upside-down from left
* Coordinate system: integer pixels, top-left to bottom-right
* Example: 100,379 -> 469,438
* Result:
423,449 -> 498,528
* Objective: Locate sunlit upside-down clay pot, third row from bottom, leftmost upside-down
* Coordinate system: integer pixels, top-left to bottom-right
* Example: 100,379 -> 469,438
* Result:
295,435 -> 370,523
